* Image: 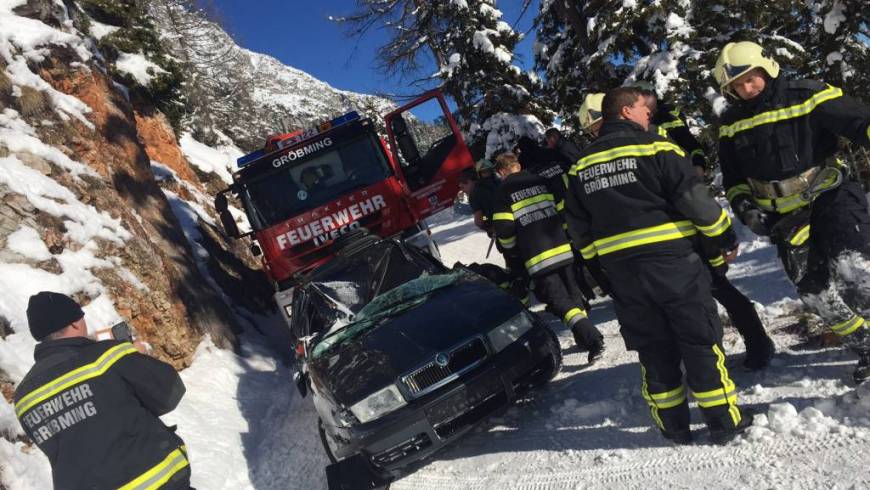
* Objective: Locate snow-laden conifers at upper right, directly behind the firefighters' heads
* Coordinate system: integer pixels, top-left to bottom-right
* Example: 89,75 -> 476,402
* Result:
535,0 -> 870,143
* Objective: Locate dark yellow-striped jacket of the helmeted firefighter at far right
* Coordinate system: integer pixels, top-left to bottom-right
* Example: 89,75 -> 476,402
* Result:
719,77 -> 870,214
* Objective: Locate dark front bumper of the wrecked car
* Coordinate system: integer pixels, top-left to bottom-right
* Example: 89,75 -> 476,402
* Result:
329,325 -> 561,474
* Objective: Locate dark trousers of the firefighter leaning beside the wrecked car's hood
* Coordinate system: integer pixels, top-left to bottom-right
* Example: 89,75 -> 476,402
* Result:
534,264 -> 603,348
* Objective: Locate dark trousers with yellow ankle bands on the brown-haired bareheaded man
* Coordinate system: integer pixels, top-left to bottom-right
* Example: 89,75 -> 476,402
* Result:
604,252 -> 742,433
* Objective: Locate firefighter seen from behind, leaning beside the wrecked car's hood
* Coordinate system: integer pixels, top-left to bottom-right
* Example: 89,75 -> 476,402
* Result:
493,153 -> 604,363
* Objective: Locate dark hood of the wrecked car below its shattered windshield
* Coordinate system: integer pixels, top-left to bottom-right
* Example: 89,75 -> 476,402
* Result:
309,278 -> 522,406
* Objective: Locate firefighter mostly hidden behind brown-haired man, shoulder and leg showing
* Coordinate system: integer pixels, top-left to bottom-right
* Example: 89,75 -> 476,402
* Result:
630,82 -> 776,370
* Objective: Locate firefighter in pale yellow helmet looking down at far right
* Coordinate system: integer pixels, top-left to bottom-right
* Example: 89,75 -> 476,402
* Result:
713,41 -> 870,382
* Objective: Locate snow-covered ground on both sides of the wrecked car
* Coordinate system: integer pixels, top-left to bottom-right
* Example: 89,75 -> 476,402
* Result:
0,211 -> 870,490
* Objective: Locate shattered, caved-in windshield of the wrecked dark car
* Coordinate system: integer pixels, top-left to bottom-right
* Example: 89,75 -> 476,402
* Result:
310,241 -> 462,357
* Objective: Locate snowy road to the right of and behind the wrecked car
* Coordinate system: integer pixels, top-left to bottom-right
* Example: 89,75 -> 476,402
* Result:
393,213 -> 870,489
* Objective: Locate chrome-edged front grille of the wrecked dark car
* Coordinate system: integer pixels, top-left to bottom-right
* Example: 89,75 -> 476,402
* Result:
402,337 -> 486,398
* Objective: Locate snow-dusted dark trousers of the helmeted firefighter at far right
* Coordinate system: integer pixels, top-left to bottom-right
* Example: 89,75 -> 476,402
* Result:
777,181 -> 870,351
